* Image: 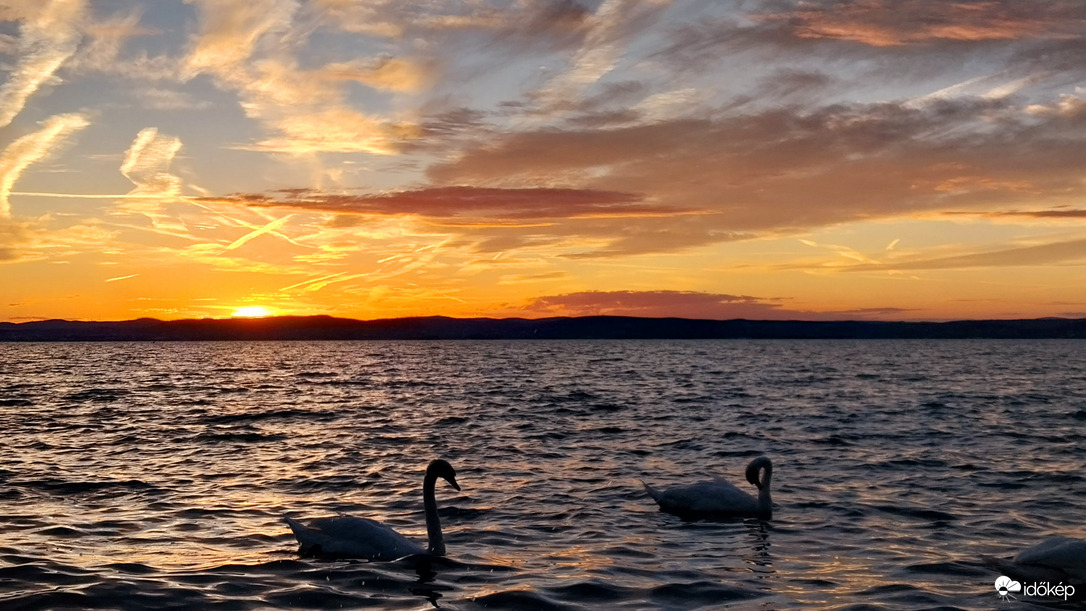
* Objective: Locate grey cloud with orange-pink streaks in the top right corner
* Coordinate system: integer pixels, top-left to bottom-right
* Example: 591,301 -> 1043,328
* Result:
652,0 -> 1086,92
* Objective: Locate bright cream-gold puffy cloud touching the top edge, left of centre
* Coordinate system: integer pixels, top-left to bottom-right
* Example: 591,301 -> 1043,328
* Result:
186,0 -> 430,155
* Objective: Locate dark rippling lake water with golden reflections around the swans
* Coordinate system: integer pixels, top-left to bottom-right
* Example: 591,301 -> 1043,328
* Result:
0,341 -> 1086,610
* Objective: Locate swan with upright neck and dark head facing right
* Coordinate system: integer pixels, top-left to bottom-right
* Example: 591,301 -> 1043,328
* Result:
285,458 -> 460,560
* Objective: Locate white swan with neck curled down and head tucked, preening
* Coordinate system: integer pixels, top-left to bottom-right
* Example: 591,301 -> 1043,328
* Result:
642,456 -> 773,520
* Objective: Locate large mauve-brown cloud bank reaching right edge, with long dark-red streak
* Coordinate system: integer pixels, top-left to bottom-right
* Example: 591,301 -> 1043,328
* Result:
195,79 -> 1086,258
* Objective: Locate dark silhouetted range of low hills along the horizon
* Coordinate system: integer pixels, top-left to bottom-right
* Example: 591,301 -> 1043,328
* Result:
0,316 -> 1086,342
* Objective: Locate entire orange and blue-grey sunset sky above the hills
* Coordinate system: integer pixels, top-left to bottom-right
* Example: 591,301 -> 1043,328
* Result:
0,0 -> 1086,322
